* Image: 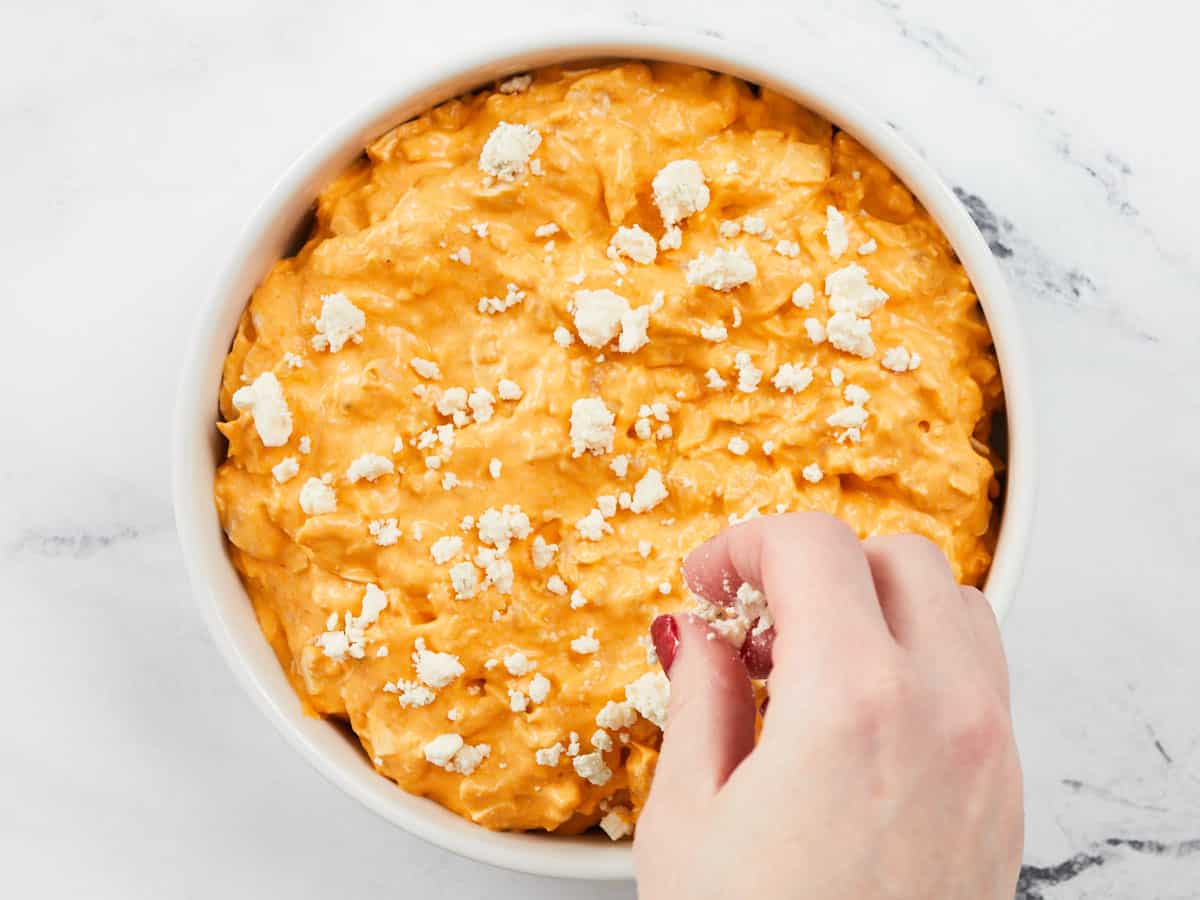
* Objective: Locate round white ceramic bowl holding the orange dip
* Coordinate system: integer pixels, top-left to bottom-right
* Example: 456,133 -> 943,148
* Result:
173,26 -> 1034,878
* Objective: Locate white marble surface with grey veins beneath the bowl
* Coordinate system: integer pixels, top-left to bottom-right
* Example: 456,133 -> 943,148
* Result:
0,0 -> 1200,900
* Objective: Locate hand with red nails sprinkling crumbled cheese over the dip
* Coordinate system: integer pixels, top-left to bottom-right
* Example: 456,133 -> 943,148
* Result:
634,514 -> 1022,900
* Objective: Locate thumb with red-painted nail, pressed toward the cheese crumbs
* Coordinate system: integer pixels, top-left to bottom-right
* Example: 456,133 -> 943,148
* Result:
648,616 -> 755,812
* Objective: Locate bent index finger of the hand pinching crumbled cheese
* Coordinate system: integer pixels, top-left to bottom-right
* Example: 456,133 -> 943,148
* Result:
684,512 -> 892,694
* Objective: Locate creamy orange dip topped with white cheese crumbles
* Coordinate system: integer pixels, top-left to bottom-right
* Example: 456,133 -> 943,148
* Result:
216,62 -> 1001,836
